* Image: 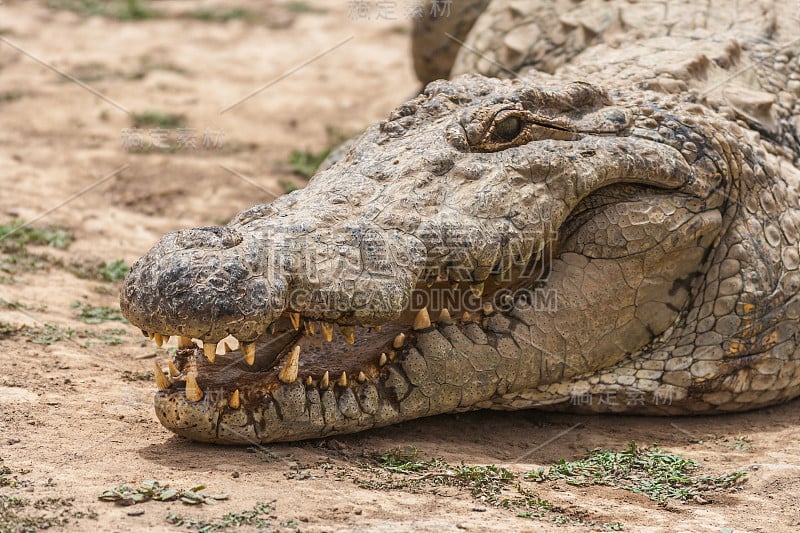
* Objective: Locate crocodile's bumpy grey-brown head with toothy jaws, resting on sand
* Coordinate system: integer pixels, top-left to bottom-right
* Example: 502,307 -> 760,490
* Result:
121,75 -> 728,443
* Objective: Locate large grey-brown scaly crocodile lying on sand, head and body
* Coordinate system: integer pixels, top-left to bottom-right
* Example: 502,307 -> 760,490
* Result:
121,0 -> 800,443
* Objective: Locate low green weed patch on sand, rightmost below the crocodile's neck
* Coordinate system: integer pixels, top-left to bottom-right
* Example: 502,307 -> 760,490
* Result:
525,442 -> 747,501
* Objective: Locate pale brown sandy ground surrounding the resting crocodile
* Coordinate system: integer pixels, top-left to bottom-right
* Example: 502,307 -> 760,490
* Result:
0,0 -> 800,532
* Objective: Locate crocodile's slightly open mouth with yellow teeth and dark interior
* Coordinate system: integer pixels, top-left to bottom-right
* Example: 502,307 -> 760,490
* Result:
148,310 -> 412,408
